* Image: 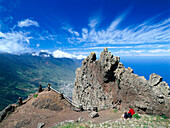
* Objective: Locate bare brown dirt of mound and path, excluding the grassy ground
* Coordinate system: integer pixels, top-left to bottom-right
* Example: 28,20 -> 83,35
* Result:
0,91 -> 122,128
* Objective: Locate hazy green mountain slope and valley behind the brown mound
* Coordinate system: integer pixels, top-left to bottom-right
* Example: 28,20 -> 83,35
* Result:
0,53 -> 82,110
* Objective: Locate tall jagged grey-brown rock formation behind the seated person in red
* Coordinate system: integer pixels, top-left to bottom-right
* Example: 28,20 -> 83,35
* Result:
73,48 -> 170,117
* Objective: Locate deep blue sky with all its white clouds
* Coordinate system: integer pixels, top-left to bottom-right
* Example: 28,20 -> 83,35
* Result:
0,0 -> 170,58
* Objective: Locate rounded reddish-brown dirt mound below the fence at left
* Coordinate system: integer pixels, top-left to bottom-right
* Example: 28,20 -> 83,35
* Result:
0,90 -> 88,128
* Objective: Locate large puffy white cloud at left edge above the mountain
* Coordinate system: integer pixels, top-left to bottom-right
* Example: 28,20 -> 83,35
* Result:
0,32 -> 32,53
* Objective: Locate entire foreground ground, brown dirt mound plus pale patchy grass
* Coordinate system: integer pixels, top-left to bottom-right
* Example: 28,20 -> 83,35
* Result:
0,89 -> 170,128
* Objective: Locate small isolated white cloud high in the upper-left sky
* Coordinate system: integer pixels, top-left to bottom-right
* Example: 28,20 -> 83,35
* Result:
18,19 -> 39,28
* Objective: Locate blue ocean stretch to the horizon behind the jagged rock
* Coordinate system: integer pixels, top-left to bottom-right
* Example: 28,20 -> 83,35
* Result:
120,56 -> 170,86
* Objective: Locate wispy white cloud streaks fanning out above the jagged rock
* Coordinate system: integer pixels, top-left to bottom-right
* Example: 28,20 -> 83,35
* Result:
66,12 -> 170,46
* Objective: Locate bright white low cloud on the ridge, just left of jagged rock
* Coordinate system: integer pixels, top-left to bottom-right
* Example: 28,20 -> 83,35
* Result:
52,50 -> 86,59
